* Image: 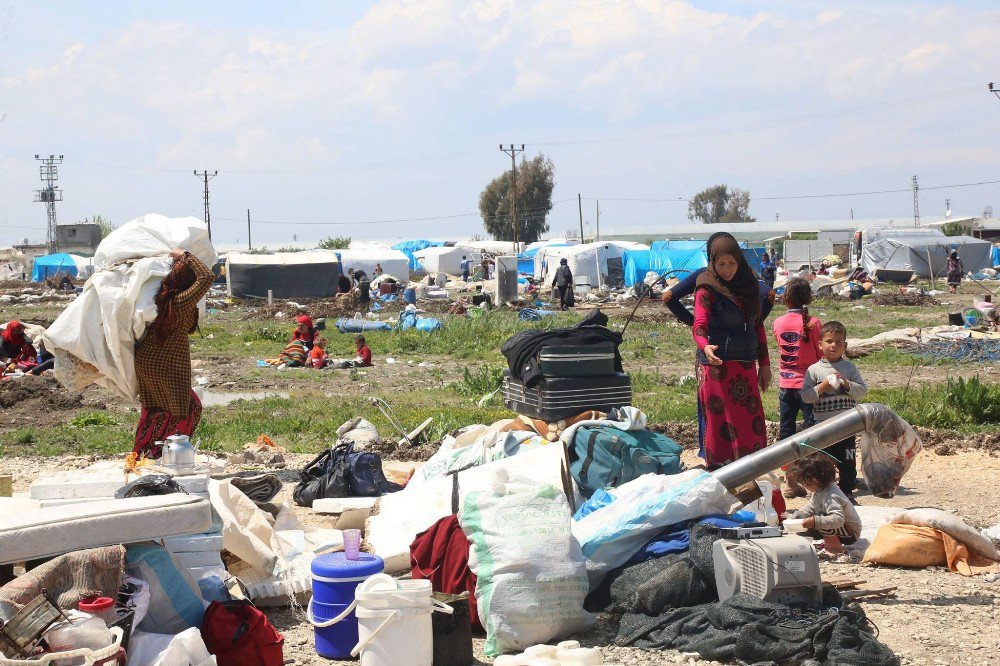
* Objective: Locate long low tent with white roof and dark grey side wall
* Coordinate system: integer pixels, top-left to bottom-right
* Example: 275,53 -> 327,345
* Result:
226,250 -> 341,298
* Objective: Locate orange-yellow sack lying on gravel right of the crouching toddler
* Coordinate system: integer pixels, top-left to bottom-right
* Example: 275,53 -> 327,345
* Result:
862,523 -> 1000,576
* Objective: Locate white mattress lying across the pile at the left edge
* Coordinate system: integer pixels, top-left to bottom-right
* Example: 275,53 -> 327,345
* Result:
0,494 -> 212,564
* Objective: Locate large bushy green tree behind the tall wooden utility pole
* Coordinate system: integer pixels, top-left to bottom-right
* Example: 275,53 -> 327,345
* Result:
479,153 -> 556,243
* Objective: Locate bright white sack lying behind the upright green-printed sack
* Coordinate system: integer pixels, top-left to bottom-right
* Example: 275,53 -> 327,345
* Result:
365,444 -> 564,573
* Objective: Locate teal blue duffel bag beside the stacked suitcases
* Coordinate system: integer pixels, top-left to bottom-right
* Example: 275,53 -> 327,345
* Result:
569,425 -> 682,497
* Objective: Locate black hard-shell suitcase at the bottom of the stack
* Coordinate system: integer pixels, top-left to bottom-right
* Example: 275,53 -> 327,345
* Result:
503,371 -> 632,421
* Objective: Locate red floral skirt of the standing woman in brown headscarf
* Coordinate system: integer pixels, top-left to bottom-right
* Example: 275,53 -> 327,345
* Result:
698,361 -> 767,469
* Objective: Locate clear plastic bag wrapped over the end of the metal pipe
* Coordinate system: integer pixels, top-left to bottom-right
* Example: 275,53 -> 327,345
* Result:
859,412 -> 924,498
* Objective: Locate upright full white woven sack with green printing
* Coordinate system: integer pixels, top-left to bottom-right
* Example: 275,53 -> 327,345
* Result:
458,471 -> 594,656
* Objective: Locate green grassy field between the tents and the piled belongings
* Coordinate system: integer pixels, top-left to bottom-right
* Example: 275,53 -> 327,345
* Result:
0,282 -> 1000,455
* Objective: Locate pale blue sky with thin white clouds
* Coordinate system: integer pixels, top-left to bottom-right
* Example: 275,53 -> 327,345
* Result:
0,0 -> 1000,246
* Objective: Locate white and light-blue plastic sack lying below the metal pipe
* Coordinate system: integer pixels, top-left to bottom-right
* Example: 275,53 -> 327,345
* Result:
573,469 -> 738,589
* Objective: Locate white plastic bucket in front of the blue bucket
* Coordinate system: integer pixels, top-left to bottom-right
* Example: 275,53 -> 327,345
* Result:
351,580 -> 452,666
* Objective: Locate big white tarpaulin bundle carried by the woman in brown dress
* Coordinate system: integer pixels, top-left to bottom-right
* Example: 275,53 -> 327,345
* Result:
44,214 -> 218,400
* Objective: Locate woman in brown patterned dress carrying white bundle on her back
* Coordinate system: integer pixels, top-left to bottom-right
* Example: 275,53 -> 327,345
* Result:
132,250 -> 215,458
